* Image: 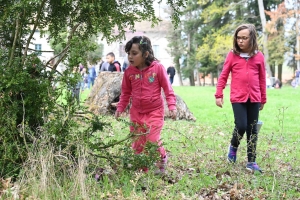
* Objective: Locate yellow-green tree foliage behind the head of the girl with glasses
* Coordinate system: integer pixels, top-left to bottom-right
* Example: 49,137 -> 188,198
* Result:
166,0 -> 295,85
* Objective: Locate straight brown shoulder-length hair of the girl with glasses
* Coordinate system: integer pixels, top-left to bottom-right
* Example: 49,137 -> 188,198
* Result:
233,24 -> 258,56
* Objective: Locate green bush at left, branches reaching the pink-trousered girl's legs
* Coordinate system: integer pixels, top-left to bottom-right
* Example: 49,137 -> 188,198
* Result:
0,51 -> 158,177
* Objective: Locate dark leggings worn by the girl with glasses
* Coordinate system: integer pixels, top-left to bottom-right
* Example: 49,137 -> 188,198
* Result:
231,99 -> 260,162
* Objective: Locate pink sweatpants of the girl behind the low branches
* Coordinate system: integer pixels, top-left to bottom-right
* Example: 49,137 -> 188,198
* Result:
130,108 -> 166,158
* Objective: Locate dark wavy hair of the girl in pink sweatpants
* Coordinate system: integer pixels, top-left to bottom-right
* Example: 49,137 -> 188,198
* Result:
125,36 -> 157,66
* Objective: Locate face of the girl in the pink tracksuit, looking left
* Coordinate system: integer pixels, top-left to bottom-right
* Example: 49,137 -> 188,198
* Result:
128,43 -> 149,69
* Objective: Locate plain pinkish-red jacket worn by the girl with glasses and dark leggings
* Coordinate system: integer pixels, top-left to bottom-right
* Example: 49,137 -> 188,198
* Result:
215,51 -> 267,104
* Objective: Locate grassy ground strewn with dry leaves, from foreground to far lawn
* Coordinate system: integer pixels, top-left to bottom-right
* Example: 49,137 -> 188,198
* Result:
5,86 -> 300,200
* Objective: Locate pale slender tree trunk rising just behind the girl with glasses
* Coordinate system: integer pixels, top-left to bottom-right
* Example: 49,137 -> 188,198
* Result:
257,0 -> 272,77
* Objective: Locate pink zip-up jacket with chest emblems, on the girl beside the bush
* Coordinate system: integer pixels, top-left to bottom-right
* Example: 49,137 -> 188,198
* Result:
117,61 -> 176,113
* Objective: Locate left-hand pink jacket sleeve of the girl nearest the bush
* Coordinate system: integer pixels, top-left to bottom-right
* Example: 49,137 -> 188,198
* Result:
117,71 -> 131,112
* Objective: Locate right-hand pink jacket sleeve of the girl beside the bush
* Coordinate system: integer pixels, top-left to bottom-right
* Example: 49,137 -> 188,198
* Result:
158,64 -> 176,110
